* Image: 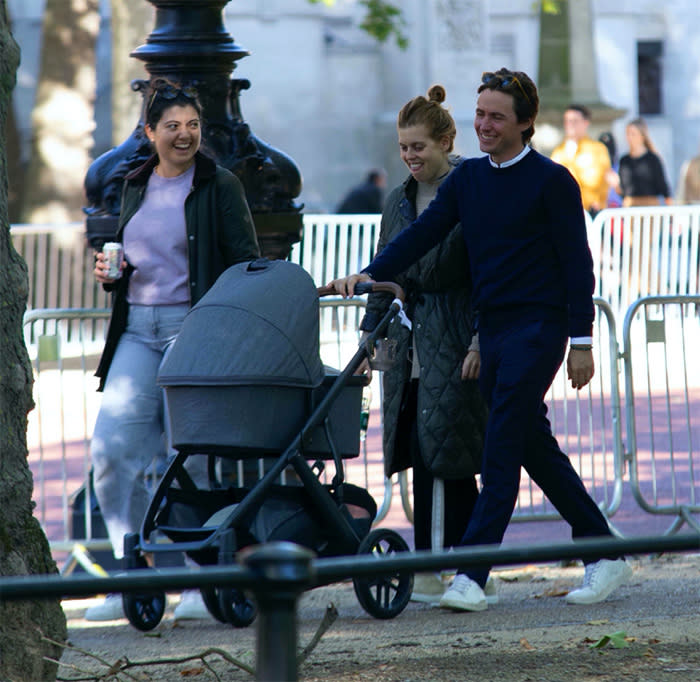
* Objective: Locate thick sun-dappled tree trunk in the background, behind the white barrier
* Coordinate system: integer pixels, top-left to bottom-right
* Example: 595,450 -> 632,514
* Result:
22,0 -> 100,223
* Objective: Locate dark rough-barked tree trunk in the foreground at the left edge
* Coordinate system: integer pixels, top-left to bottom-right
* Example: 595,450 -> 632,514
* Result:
0,0 -> 66,682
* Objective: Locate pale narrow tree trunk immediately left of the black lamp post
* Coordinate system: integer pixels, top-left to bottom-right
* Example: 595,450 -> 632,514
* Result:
112,0 -> 154,147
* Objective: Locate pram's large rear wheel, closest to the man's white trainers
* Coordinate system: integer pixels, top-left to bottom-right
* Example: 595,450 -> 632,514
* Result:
352,528 -> 413,619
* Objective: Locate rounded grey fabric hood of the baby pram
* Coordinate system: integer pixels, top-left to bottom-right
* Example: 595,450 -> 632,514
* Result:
158,259 -> 325,388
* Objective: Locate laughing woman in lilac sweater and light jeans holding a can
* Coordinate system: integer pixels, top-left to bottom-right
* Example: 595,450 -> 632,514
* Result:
86,80 -> 259,620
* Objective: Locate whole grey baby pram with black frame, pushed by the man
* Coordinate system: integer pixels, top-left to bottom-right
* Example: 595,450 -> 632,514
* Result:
123,259 -> 413,630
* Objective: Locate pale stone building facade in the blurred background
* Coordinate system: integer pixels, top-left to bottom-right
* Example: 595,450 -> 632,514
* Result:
8,0 -> 700,212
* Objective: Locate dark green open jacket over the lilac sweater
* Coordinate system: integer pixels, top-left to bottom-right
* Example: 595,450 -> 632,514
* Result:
95,152 -> 260,390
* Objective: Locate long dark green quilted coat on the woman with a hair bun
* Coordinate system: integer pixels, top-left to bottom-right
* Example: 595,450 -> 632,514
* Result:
361,160 -> 486,479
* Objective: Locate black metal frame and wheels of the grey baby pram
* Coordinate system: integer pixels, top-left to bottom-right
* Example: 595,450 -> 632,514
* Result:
123,282 -> 413,630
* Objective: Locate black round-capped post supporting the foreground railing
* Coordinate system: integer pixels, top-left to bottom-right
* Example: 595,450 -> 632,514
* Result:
240,542 -> 315,682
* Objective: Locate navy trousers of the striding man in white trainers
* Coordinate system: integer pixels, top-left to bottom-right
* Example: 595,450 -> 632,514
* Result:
461,308 -> 611,587
